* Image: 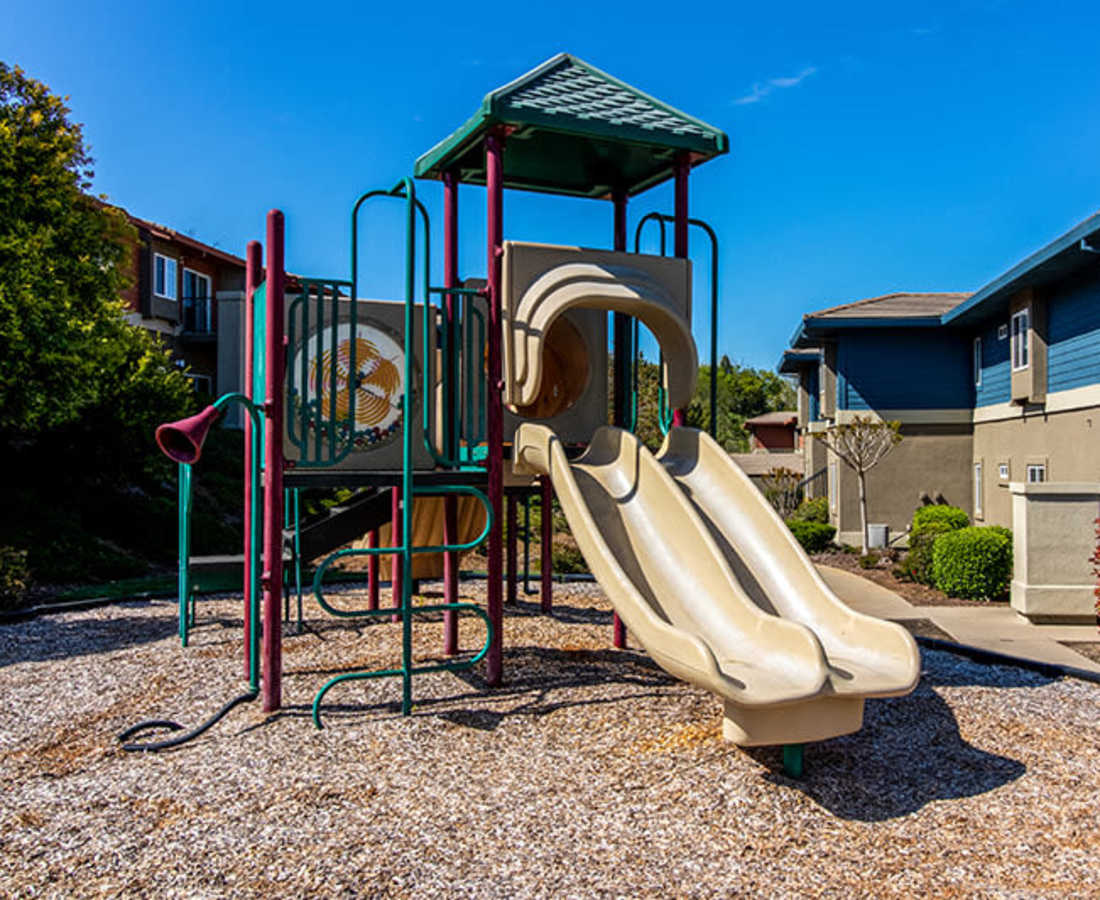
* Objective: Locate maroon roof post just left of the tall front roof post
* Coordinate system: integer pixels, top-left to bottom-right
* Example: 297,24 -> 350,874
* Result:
443,172 -> 459,656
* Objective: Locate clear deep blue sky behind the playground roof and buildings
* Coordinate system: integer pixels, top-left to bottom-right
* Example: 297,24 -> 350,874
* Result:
0,0 -> 1100,367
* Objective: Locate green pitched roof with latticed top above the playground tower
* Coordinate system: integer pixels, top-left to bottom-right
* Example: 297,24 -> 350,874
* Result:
414,53 -> 729,197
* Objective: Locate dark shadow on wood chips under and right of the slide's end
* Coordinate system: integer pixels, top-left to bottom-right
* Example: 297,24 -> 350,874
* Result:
747,651 -> 1052,822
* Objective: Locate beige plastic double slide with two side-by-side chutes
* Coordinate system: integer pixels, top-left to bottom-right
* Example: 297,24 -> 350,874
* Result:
515,424 -> 920,745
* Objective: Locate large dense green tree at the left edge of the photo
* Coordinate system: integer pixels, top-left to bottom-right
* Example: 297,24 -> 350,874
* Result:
0,62 -> 195,578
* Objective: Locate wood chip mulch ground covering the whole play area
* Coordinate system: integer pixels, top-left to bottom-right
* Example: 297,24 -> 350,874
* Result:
0,582 -> 1100,898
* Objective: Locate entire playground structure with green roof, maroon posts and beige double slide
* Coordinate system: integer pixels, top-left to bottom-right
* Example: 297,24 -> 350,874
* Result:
137,54 -> 919,770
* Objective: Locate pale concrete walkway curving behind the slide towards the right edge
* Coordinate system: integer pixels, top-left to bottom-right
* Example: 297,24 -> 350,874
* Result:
817,566 -> 1100,672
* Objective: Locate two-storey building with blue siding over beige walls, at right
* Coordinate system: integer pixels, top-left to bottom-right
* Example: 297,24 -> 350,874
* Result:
780,215 -> 1100,544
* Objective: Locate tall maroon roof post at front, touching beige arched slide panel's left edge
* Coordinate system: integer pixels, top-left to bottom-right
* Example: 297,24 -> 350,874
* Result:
485,133 -> 504,687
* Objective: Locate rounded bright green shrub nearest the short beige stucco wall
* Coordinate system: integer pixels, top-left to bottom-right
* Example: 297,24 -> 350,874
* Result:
932,527 -> 1012,600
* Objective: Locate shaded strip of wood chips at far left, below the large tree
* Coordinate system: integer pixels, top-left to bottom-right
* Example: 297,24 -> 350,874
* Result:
0,601 -> 177,668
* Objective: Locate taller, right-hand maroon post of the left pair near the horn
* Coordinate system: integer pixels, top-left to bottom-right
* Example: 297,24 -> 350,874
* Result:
263,209 -> 286,713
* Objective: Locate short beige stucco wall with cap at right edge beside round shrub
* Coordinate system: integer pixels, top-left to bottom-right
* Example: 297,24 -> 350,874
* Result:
1010,481 -> 1100,622
